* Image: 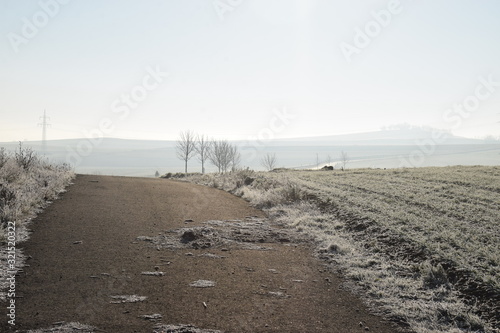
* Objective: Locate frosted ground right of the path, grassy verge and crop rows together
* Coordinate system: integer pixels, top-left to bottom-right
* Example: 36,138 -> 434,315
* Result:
188,166 -> 500,333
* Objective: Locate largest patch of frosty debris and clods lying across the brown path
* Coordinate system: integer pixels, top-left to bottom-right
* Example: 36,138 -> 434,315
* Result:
136,217 -> 308,251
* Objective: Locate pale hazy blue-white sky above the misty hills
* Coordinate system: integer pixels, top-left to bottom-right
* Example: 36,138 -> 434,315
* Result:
0,0 -> 500,141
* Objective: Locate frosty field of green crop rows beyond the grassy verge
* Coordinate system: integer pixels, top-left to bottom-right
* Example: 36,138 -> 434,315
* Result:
280,167 -> 500,289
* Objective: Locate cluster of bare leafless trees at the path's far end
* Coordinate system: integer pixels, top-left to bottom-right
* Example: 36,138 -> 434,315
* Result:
176,131 -> 241,173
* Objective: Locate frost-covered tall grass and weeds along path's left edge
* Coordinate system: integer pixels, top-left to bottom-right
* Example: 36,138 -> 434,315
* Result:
0,146 -> 74,300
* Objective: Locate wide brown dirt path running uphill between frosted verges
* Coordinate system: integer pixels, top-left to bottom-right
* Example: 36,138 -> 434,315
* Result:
0,175 -> 394,332
